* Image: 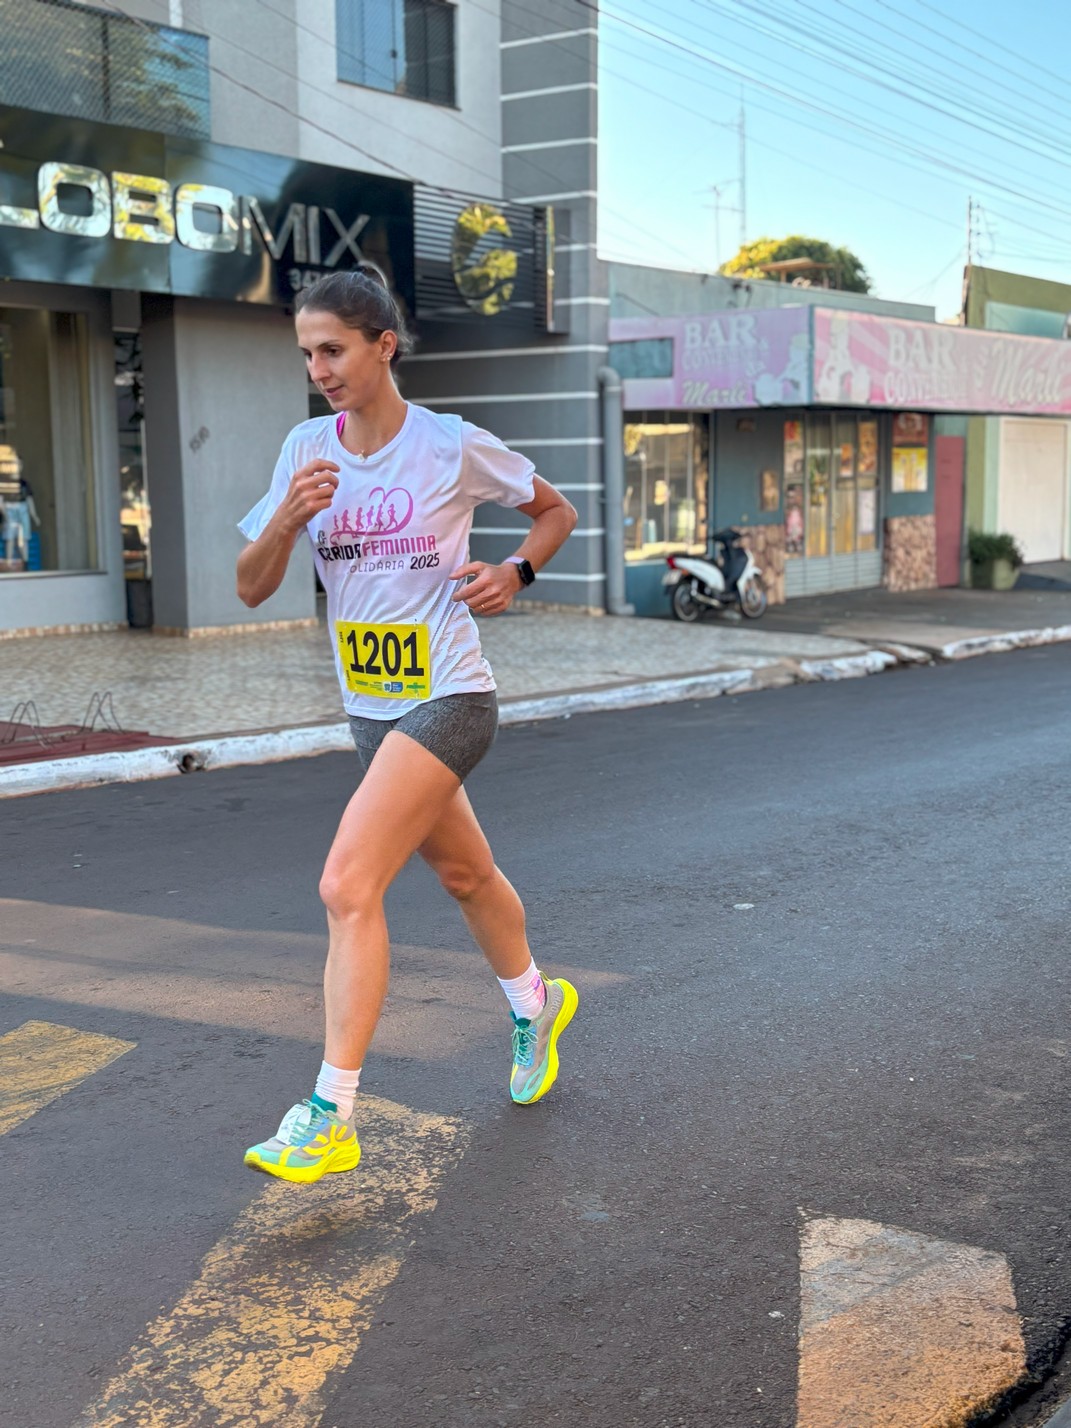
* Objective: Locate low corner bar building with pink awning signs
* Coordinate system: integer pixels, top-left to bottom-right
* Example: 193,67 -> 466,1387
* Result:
610,291 -> 1071,613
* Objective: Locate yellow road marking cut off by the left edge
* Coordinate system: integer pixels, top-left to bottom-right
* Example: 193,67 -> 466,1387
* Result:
0,1021 -> 136,1135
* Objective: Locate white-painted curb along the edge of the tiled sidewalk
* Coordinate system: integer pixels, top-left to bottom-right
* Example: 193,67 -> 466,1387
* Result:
0,625 -> 1071,805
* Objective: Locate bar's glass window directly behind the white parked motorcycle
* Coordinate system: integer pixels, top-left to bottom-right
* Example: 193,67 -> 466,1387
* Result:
624,411 -> 710,560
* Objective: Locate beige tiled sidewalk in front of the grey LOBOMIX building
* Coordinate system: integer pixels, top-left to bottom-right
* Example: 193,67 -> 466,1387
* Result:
0,611 -> 865,740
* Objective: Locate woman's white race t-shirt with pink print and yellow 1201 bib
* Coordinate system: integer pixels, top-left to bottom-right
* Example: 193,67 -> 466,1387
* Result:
238,403 -> 536,720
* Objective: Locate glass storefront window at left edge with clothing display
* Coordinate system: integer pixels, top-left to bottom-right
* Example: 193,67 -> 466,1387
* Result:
0,307 -> 97,575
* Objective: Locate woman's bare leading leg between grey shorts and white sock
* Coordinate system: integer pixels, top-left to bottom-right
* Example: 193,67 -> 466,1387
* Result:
320,730 -> 465,1071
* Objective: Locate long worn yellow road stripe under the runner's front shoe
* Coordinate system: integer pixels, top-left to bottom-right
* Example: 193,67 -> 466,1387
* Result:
77,1097 -> 466,1428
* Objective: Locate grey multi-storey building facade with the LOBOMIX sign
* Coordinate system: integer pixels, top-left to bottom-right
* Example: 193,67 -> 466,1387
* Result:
0,0 -> 607,634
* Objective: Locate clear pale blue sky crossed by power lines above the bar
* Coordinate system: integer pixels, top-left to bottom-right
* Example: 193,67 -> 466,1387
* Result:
600,0 -> 1071,317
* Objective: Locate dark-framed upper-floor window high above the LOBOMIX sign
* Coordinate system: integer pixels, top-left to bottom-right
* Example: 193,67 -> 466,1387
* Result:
336,0 -> 457,106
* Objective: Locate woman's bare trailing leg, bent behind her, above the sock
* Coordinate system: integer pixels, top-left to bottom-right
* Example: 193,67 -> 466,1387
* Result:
420,788 -> 531,978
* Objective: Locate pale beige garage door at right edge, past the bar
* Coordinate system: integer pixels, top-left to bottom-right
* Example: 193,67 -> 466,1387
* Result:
998,417 -> 1068,560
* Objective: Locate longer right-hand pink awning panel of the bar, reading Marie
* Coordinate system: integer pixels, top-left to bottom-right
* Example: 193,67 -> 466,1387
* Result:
814,308 -> 1071,416
